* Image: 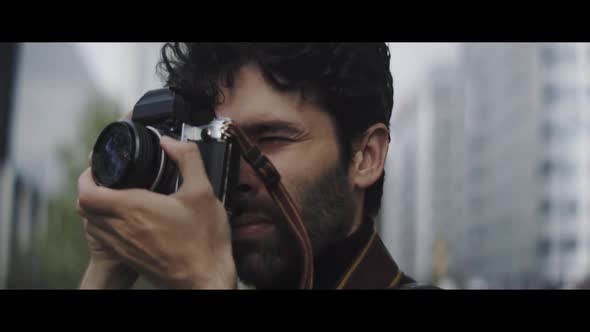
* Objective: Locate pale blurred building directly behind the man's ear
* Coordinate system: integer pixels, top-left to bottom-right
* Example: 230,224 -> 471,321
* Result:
381,65 -> 465,283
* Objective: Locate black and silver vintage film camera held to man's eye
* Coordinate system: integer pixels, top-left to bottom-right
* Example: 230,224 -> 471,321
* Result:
92,88 -> 240,213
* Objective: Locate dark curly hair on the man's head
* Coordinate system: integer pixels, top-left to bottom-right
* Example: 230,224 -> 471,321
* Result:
158,43 -> 393,218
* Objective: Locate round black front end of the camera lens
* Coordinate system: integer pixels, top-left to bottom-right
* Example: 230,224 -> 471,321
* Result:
92,121 -> 164,189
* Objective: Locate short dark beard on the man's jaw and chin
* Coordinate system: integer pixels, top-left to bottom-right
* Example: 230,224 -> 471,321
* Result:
232,163 -> 355,288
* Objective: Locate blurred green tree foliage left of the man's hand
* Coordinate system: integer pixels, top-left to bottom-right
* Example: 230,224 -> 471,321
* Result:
33,96 -> 122,289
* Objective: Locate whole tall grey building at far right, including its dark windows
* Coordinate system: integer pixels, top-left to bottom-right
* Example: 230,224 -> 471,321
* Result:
462,43 -> 590,287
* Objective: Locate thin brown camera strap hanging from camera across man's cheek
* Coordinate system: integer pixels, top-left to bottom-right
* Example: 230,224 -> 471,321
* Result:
228,124 -> 320,289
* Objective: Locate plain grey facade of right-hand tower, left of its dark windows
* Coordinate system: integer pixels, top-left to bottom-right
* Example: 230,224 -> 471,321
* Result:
452,44 -> 542,288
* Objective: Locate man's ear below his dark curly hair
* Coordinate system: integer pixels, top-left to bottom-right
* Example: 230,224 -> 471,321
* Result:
349,123 -> 389,189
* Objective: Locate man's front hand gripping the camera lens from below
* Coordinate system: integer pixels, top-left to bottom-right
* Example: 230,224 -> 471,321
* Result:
78,137 -> 237,288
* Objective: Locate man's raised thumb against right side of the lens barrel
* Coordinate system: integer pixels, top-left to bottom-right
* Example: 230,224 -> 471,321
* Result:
161,136 -> 213,196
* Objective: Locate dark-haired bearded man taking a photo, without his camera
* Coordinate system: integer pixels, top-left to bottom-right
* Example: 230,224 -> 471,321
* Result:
78,43 -> 430,289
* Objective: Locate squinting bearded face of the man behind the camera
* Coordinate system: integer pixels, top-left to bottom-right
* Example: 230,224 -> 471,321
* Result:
216,66 -> 357,287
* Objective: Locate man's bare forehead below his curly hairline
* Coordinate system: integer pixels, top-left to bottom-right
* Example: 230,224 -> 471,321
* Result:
216,65 -> 327,126
